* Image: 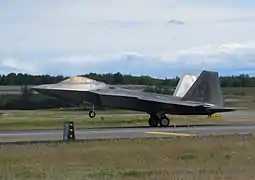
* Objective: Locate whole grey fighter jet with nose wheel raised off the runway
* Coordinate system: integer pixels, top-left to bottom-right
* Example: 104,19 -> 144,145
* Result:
32,70 -> 235,127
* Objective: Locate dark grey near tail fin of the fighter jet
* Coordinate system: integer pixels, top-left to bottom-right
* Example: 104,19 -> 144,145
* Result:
182,71 -> 223,106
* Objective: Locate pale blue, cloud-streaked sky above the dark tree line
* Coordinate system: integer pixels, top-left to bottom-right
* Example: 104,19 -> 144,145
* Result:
0,0 -> 255,78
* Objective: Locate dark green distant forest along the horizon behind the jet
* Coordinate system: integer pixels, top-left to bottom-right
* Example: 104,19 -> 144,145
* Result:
0,72 -> 255,87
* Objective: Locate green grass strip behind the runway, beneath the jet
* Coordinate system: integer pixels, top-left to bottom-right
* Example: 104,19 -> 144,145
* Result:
0,110 -> 239,130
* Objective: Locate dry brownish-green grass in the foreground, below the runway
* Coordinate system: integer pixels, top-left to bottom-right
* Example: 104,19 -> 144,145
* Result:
0,136 -> 255,180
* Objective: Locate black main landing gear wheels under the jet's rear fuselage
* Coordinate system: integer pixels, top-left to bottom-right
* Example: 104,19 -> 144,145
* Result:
148,113 -> 170,127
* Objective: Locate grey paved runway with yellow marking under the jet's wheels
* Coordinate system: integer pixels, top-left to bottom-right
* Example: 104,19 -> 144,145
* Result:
0,123 -> 255,142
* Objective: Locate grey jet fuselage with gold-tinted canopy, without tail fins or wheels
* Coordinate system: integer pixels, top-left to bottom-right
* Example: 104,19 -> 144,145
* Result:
32,78 -> 235,115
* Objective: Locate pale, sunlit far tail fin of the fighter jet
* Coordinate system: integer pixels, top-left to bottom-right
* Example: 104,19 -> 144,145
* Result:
173,74 -> 197,97
